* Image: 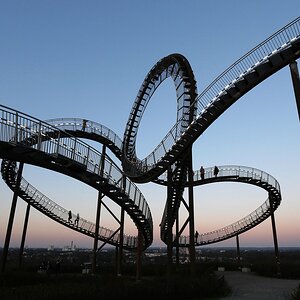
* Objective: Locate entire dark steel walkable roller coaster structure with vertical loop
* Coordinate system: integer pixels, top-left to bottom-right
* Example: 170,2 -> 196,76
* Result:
0,17 -> 300,270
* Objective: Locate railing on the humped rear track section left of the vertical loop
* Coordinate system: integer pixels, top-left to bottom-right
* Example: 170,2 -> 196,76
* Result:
45,118 -> 123,155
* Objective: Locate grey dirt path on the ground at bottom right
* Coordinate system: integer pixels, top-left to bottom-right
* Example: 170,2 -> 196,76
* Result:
218,271 -> 300,300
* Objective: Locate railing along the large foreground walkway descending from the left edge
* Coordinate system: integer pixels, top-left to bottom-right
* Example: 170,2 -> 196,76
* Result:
0,105 -> 152,237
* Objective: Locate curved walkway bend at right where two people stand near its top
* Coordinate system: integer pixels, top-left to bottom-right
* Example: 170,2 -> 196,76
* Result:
160,166 -> 281,246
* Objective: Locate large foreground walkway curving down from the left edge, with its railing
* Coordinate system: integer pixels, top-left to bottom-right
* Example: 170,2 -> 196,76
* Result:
0,106 -> 153,248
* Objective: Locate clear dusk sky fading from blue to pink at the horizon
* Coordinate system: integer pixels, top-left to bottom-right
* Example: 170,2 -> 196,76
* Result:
0,0 -> 300,248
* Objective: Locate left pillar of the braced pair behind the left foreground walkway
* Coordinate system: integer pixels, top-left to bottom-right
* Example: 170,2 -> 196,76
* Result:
92,145 -> 106,274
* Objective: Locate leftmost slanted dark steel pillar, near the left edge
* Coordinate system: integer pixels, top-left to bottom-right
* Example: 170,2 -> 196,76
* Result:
1,162 -> 24,272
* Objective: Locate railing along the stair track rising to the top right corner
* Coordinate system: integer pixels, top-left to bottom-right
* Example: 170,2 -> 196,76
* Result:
137,17 -> 300,172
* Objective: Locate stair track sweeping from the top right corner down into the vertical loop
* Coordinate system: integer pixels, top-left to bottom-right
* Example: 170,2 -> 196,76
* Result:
123,17 -> 300,182
